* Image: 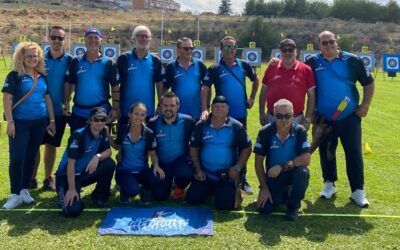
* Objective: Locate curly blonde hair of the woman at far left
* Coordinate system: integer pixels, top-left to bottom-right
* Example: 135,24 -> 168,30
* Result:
13,42 -> 46,75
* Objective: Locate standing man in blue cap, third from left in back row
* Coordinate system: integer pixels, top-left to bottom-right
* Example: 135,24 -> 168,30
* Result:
67,28 -> 119,131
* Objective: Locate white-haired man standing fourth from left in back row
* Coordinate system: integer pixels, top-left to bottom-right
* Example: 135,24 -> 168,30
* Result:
117,25 -> 163,139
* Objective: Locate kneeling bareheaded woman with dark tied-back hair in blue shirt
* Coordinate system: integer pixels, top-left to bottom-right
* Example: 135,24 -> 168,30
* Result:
110,103 -> 165,204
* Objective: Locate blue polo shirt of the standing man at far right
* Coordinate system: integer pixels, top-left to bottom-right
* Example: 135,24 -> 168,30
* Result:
306,51 -> 374,120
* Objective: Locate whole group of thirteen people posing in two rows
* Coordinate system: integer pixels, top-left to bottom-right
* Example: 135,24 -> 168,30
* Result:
2,25 -> 374,220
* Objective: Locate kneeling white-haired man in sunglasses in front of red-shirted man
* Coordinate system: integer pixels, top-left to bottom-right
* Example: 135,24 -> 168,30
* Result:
254,99 -> 311,221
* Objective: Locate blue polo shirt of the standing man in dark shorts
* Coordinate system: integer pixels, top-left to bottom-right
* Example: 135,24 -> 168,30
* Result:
44,49 -> 72,116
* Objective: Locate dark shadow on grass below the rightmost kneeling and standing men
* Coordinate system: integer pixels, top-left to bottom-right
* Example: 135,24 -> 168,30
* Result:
245,199 -> 373,246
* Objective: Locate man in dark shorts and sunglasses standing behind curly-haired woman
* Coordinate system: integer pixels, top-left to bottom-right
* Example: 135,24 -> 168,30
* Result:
31,26 -> 72,190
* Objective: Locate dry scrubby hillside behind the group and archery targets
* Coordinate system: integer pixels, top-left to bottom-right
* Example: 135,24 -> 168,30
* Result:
0,4 -> 400,58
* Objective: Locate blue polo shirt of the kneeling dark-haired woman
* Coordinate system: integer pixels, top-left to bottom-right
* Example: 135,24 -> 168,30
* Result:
120,127 -> 157,173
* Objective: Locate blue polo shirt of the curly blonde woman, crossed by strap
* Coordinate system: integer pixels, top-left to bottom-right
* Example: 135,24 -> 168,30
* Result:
2,71 -> 48,120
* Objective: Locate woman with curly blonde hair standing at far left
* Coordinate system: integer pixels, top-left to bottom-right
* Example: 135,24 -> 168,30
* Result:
2,42 -> 55,209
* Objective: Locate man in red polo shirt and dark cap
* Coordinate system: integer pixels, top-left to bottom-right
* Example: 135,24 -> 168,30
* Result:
259,39 -> 315,130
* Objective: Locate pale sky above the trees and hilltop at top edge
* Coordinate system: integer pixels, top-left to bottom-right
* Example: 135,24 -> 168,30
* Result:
175,0 -> 400,14
